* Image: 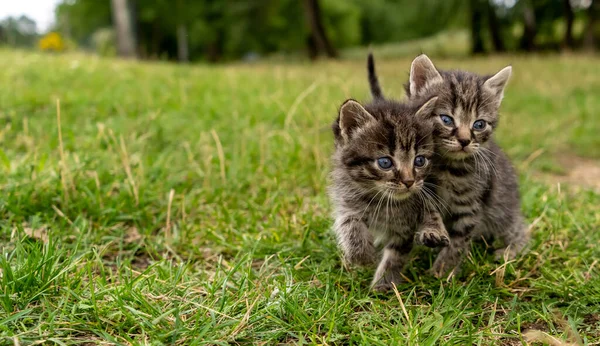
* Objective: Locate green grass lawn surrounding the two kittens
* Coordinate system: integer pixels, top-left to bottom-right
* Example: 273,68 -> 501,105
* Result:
0,51 -> 600,345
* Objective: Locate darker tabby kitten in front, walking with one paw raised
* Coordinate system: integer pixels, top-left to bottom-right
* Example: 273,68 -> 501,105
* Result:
330,93 -> 447,291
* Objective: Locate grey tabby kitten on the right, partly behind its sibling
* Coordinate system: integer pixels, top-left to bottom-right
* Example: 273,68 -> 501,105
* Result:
405,55 -> 528,276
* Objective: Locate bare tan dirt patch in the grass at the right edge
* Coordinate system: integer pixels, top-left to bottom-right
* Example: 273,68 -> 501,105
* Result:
543,155 -> 600,192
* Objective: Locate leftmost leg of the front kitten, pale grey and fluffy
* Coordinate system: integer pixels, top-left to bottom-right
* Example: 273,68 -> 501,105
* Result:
333,217 -> 375,266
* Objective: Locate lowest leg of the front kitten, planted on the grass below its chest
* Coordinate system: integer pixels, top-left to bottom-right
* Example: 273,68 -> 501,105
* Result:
371,241 -> 412,292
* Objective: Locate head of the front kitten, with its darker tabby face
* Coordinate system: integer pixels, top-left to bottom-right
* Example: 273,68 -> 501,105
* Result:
334,100 -> 435,200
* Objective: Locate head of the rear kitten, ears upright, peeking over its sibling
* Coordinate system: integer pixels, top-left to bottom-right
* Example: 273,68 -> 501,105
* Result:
407,55 -> 511,159
